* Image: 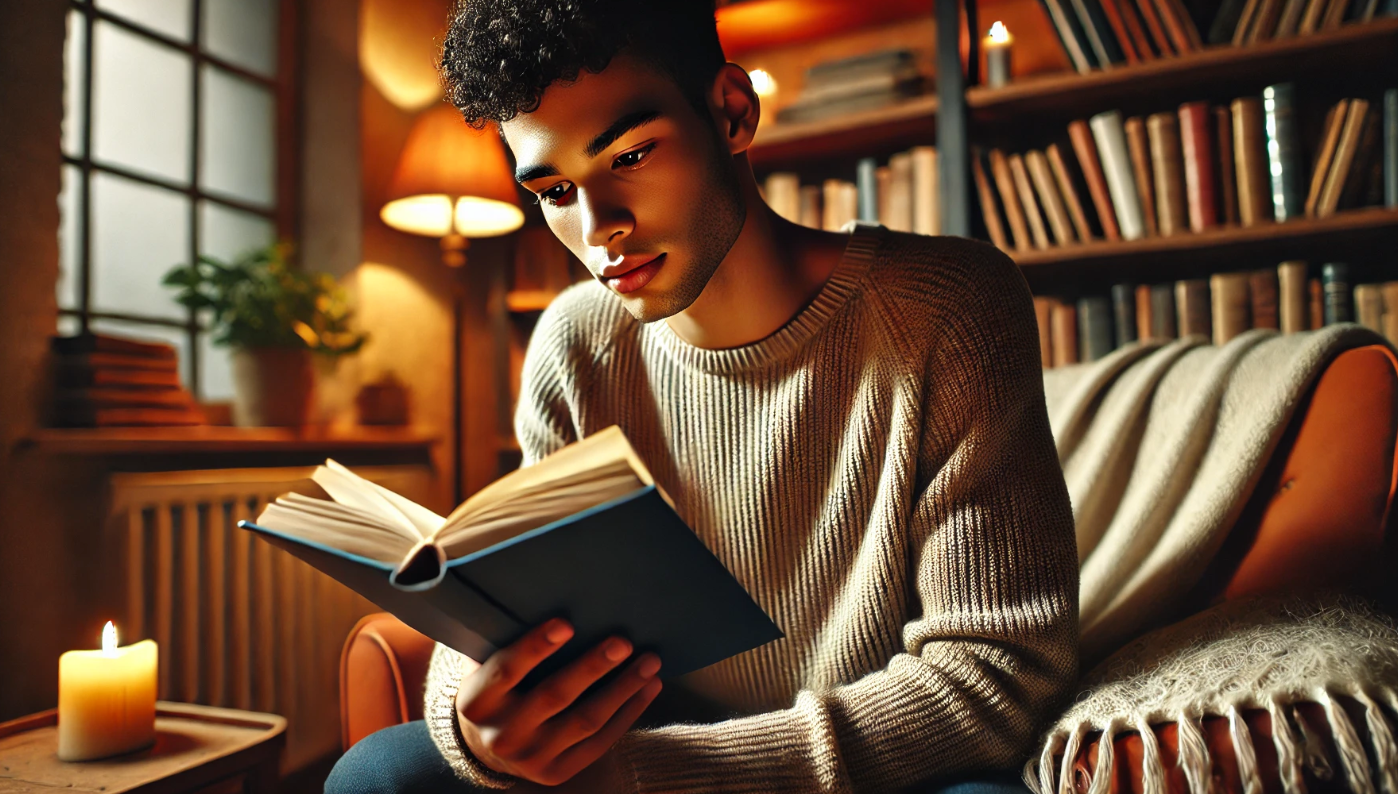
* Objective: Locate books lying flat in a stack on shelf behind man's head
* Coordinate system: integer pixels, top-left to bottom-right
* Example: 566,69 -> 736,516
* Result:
777,49 -> 924,124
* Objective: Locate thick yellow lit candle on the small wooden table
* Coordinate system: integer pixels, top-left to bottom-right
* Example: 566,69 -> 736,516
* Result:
59,621 -> 157,760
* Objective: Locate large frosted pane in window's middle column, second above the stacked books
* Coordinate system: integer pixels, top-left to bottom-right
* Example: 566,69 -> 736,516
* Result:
92,21 -> 193,183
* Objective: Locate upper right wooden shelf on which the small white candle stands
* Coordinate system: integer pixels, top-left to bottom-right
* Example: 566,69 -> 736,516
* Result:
966,18 -> 1398,124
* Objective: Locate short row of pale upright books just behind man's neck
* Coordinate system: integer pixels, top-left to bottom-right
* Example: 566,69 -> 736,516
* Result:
762,147 -> 942,235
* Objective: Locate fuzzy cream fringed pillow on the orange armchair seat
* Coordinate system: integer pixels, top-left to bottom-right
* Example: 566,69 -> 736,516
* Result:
1025,596 -> 1398,794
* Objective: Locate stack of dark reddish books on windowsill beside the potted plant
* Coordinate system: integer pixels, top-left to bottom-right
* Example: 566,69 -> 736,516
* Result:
52,334 -> 206,428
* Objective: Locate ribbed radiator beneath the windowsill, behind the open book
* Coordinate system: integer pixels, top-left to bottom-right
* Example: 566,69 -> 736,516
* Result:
112,467 -> 431,773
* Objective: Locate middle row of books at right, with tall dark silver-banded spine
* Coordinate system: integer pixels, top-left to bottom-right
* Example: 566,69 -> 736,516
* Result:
972,84 -> 1398,250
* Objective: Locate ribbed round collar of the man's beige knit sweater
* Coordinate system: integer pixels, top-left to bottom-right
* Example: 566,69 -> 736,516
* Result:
643,225 -> 882,375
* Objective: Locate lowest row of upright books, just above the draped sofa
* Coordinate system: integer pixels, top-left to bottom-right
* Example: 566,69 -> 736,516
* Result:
1035,261 -> 1398,369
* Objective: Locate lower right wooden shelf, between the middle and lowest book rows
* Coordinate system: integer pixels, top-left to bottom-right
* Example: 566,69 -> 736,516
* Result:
1011,207 -> 1398,289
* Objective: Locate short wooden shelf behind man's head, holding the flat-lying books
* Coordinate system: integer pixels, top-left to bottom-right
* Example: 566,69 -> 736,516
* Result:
748,94 -> 937,171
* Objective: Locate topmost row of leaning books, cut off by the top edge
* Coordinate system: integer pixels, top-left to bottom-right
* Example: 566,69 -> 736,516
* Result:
1039,0 -> 1398,73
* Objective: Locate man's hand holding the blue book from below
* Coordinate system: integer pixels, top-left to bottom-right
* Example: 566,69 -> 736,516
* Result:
456,619 -> 660,786
